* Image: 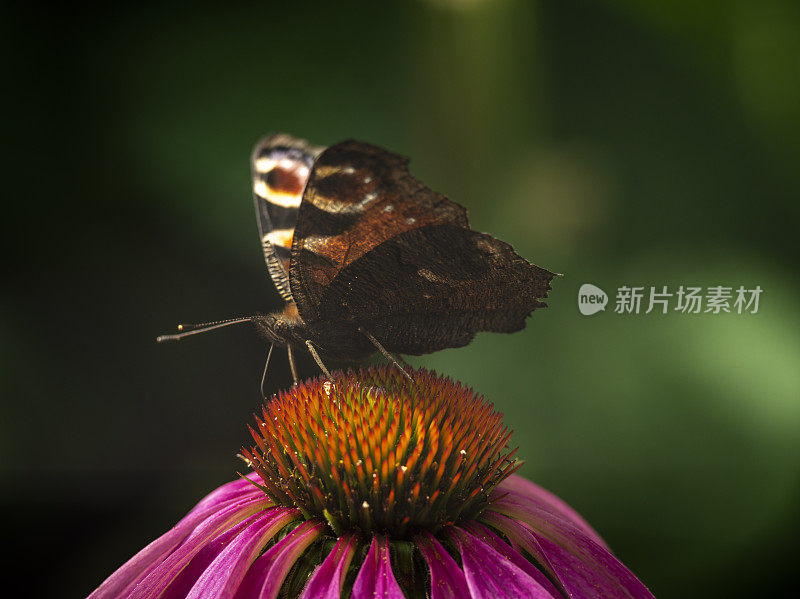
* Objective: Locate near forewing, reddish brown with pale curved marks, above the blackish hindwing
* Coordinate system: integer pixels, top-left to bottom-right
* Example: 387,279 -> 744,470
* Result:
289,140 -> 469,322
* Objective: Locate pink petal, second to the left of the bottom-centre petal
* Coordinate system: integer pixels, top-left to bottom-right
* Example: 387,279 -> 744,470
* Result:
236,520 -> 327,599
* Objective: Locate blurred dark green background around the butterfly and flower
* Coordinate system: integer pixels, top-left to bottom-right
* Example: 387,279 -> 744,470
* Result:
0,0 -> 800,598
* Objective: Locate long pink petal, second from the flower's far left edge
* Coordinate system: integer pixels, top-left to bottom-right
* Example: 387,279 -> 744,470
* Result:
126,495 -> 282,599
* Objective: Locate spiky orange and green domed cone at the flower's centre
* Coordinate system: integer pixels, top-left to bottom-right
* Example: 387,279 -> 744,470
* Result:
243,366 -> 516,539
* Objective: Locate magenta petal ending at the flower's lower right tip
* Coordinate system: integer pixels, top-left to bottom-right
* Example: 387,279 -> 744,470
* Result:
481,505 -> 654,599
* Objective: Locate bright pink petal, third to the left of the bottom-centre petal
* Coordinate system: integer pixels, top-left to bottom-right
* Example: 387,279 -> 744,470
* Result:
186,508 -> 302,599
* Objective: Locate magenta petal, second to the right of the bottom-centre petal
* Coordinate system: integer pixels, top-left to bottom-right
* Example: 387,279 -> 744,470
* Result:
447,527 -> 559,599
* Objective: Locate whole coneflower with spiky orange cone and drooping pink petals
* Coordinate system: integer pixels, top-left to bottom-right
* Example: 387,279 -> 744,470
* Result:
90,367 -> 652,599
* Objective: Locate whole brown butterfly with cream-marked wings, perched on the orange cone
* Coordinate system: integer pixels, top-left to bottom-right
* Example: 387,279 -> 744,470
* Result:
159,134 -> 555,390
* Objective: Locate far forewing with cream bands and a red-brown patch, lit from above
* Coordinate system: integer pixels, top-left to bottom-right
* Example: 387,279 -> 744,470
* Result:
250,134 -> 323,301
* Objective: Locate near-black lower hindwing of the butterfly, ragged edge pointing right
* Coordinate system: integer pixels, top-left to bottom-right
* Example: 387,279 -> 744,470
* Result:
318,225 -> 555,355
